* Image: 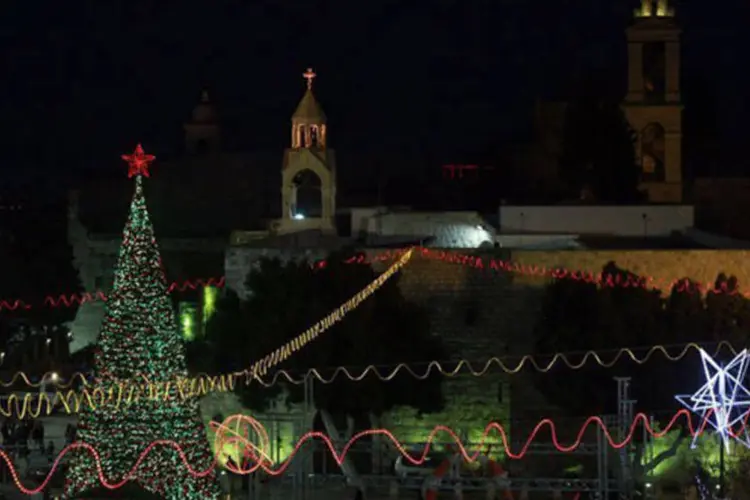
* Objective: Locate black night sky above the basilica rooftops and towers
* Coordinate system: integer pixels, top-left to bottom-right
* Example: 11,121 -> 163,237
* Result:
0,0 -> 750,186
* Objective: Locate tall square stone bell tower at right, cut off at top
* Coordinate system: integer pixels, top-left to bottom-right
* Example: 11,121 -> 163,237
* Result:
622,0 -> 683,203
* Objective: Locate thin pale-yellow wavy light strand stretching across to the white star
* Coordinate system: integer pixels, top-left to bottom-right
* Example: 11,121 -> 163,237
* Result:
0,340 -> 739,389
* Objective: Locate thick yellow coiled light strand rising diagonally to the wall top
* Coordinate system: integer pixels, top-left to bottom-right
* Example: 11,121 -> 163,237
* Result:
0,252 -> 412,418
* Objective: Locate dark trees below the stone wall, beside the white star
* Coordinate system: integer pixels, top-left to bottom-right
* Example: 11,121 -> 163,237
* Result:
535,263 -> 750,482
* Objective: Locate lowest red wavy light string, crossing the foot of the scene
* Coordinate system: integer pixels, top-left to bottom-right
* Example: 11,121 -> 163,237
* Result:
0,410 -> 736,495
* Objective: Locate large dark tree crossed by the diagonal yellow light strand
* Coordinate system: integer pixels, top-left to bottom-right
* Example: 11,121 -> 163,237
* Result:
204,252 -> 445,417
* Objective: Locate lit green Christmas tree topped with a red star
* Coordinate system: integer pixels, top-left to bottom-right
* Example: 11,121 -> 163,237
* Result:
64,145 -> 220,500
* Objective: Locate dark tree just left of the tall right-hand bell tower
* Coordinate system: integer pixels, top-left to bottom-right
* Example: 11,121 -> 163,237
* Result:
560,99 -> 643,203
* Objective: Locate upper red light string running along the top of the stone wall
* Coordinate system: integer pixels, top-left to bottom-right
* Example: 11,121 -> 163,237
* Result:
0,248 -> 750,310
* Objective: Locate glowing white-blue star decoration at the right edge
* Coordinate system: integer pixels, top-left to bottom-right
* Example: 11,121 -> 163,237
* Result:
675,349 -> 750,452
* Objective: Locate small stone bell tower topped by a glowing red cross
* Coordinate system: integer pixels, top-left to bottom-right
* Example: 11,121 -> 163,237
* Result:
276,68 -> 336,233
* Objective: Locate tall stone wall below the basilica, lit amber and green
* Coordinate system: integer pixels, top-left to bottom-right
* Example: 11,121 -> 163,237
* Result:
70,243 -> 750,446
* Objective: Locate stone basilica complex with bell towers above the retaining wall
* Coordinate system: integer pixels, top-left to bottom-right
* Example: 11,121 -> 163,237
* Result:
68,0 -> 693,350
